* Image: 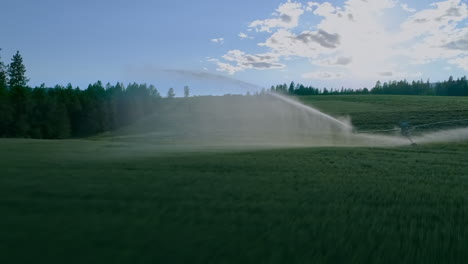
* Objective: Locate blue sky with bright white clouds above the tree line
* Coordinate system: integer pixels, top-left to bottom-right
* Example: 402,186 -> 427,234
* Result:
0,0 -> 468,94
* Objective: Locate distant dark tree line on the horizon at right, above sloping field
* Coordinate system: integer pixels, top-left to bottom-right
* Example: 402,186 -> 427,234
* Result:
270,76 -> 468,96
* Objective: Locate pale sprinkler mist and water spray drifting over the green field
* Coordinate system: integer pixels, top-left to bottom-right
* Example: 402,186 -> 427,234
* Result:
104,93 -> 468,152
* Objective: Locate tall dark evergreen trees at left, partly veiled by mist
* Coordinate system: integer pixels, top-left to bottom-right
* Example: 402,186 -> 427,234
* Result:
0,52 -> 189,139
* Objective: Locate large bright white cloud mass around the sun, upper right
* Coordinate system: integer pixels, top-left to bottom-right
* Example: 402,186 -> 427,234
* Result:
216,0 -> 468,80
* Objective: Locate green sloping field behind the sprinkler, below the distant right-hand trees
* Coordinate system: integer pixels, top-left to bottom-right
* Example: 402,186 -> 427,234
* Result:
300,95 -> 468,130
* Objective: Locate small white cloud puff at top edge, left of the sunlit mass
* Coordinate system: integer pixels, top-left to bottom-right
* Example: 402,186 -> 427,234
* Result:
249,1 -> 304,32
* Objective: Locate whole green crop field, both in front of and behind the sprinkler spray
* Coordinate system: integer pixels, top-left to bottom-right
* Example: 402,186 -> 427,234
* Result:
0,96 -> 468,263
